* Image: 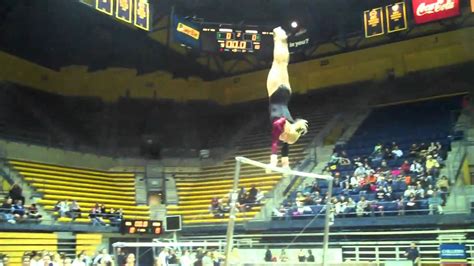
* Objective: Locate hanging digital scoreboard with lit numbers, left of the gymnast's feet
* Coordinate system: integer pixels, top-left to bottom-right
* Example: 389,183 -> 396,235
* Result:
201,27 -> 273,53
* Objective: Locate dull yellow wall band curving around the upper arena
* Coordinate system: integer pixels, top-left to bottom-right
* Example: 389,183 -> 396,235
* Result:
0,27 -> 474,105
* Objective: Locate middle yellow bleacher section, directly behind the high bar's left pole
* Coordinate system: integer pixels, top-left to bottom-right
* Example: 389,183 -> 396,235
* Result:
167,107 -> 329,224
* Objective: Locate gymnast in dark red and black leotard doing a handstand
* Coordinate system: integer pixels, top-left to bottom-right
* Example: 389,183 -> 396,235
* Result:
267,27 -> 308,172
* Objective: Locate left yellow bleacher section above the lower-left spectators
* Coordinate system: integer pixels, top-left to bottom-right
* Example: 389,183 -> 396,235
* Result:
9,160 -> 150,223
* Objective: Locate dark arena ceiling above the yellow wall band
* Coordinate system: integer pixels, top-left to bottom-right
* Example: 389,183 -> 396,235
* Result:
0,0 -> 466,80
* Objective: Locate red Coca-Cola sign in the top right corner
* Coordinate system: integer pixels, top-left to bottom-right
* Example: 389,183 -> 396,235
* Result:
412,0 -> 461,24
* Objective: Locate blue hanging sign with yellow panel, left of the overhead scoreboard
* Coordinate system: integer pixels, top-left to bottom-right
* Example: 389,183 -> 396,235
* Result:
172,15 -> 201,49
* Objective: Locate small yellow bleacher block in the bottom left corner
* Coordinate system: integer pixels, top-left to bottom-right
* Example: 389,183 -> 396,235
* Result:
0,232 -> 58,266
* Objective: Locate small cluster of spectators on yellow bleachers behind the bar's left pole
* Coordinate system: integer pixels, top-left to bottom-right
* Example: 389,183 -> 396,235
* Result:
209,185 -> 265,218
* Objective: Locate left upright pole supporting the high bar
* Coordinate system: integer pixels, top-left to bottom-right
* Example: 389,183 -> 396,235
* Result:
224,160 -> 240,266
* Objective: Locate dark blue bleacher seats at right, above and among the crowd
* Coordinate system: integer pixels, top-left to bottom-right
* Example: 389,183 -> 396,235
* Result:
284,95 -> 462,220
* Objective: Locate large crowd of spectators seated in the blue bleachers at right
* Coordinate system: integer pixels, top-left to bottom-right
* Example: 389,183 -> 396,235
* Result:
274,142 -> 449,217
